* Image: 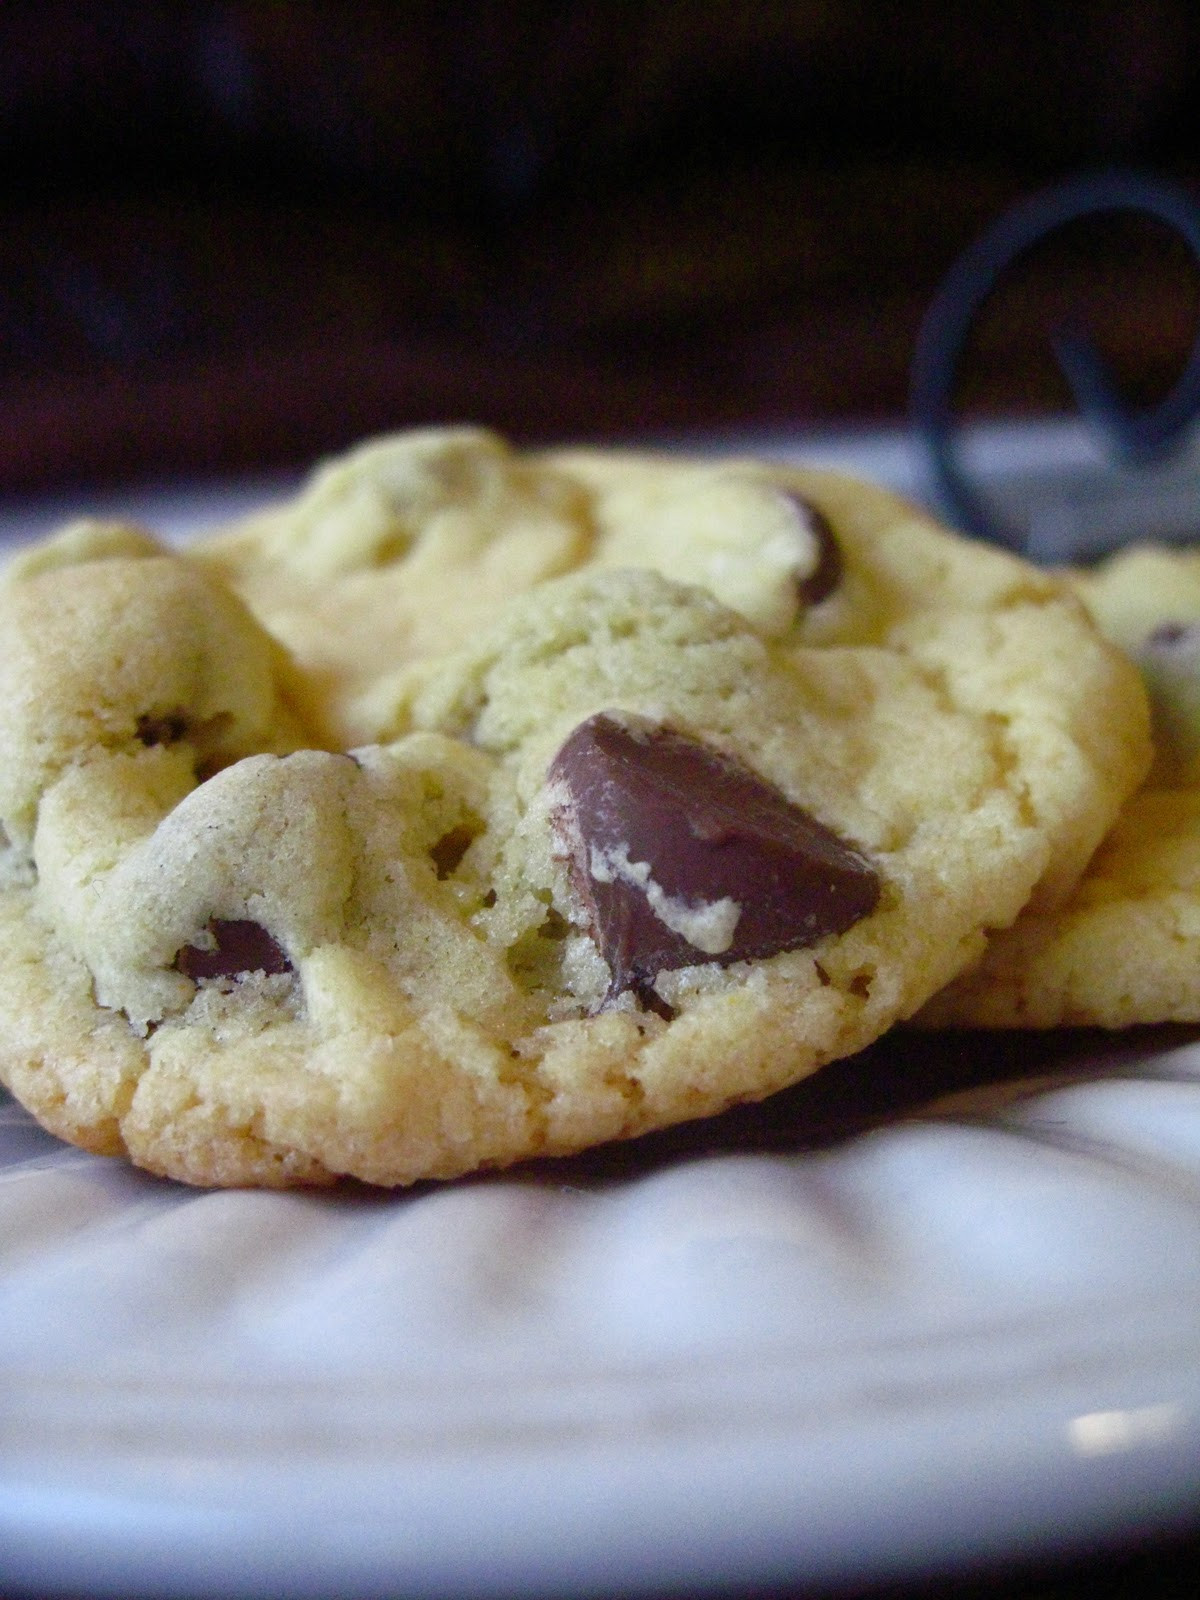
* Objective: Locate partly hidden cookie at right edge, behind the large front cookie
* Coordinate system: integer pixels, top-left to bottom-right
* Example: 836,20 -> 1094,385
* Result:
918,546 -> 1200,1029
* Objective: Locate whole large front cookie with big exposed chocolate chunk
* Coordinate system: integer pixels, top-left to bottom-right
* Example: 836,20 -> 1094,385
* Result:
0,430 -> 1149,1184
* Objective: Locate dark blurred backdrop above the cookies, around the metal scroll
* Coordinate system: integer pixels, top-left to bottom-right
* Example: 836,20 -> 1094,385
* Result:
0,0 -> 1200,490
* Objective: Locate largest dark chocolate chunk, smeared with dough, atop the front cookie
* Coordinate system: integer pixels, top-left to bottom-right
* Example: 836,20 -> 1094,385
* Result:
549,712 -> 878,1010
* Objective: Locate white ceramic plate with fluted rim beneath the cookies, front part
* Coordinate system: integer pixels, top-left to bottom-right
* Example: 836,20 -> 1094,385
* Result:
0,428 -> 1200,1597
